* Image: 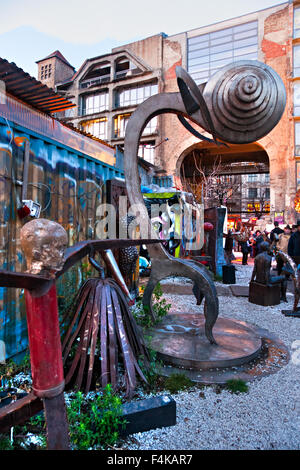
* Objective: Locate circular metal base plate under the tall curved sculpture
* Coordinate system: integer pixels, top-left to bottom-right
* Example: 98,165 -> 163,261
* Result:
149,314 -> 262,370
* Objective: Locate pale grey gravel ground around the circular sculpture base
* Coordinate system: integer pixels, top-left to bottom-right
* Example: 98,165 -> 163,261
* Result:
124,265 -> 300,450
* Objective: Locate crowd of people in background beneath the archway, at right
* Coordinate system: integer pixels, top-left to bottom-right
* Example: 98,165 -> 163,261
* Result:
224,220 -> 300,266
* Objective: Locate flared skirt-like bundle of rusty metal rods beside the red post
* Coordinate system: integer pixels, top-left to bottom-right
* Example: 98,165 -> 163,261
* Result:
62,278 -> 149,396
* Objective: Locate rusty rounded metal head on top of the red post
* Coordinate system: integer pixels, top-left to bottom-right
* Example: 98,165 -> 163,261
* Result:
20,219 -> 68,279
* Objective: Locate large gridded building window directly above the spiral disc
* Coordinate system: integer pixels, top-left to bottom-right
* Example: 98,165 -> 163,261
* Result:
188,21 -> 258,83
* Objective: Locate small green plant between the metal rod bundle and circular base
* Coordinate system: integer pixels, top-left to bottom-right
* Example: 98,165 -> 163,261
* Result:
133,283 -> 171,329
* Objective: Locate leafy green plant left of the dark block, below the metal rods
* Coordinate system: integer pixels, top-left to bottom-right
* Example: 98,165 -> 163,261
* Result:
67,384 -> 125,450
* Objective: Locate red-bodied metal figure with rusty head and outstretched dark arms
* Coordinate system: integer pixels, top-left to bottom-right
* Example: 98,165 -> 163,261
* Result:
0,235 -> 159,450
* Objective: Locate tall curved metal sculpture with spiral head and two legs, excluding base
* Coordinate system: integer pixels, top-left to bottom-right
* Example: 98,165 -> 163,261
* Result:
124,61 -> 286,344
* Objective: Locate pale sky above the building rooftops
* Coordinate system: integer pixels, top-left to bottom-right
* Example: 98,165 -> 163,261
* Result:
0,0 -> 285,77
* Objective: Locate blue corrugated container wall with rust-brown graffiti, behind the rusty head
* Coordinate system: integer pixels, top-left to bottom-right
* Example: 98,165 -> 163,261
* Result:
0,116 -> 123,357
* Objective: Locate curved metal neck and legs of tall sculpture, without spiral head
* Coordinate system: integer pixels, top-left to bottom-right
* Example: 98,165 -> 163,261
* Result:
124,84 -> 219,344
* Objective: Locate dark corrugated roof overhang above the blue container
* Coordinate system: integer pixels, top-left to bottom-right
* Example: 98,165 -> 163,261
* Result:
0,57 -> 76,114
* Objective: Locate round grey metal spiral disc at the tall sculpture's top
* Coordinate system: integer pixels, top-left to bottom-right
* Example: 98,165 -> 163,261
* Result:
203,61 -> 286,144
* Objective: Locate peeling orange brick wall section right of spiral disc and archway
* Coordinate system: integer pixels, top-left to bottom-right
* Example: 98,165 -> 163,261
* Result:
261,5 -> 296,223
